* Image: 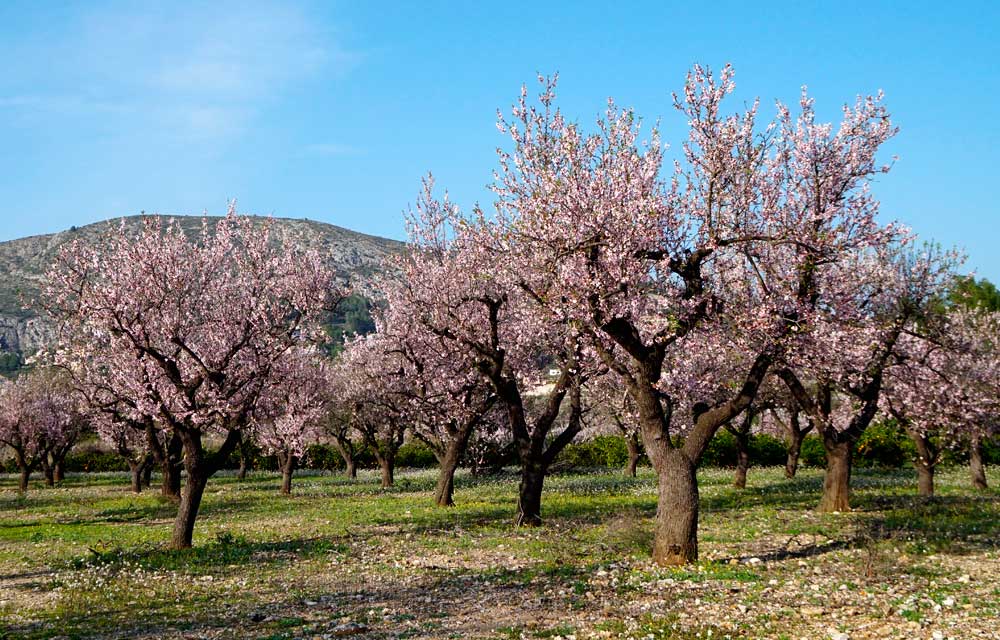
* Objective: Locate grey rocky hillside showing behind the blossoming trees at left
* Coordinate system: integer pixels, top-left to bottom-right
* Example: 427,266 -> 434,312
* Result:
0,216 -> 403,366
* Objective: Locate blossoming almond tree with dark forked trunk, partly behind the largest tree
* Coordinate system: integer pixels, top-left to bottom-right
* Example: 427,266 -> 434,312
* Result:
394,179 -> 593,525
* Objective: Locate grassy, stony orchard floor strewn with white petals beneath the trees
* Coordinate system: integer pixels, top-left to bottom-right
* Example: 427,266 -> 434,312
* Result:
0,469 -> 1000,640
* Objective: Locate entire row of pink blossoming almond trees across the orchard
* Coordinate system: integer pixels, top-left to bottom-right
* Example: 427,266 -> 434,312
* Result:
3,67 -> 1000,564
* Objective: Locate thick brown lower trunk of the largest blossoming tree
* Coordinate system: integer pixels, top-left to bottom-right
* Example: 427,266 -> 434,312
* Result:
653,449 -> 698,565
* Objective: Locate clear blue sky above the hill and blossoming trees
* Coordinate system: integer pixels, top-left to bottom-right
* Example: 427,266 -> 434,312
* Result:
0,0 -> 1000,282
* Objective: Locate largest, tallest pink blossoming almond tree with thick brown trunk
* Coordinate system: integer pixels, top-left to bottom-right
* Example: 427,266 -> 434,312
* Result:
476,67 -> 908,564
